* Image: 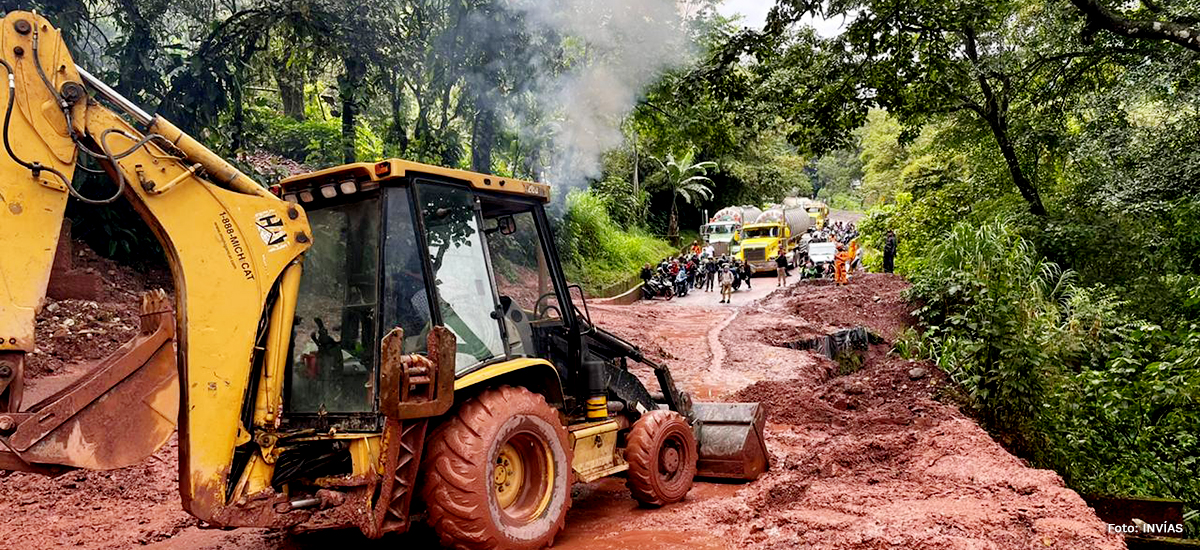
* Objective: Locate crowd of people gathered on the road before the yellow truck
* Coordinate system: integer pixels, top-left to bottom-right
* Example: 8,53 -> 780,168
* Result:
641,246 -> 754,304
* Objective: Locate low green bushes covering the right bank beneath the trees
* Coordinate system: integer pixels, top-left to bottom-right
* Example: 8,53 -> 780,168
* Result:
895,220 -> 1200,511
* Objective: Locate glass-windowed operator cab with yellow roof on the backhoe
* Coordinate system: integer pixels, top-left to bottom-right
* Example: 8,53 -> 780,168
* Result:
282,160 -> 578,431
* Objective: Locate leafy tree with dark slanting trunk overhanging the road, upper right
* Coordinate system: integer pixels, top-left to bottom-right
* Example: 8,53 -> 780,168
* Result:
718,0 -> 1145,215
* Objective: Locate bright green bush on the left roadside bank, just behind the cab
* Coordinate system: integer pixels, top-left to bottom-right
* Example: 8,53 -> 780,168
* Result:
557,191 -> 674,292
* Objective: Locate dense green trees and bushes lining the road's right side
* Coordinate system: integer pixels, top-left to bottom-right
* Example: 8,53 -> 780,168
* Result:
751,0 -> 1200,518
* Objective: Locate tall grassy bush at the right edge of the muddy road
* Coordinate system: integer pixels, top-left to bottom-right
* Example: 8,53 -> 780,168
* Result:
910,220 -> 1069,452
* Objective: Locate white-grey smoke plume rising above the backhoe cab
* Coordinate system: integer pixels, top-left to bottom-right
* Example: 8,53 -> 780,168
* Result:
511,0 -> 694,197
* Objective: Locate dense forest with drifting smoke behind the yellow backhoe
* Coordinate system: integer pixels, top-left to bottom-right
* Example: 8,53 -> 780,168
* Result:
21,0 -> 809,266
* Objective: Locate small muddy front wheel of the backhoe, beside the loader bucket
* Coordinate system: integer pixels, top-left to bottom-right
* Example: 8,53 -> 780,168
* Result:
625,411 -> 698,507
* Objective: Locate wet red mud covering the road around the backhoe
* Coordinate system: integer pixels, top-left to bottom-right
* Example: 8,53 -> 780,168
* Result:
0,259 -> 1124,550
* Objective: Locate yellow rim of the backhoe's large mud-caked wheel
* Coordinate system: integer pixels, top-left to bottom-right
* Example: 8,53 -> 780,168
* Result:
492,432 -> 554,525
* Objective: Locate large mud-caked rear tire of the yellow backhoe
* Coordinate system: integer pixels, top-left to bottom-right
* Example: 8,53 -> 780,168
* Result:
421,385 -> 572,550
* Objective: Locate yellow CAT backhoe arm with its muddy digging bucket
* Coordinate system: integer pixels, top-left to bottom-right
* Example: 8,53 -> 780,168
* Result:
0,12 -> 311,525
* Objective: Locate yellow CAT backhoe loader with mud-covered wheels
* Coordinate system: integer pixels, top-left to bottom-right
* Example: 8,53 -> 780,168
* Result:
0,12 -> 768,549
